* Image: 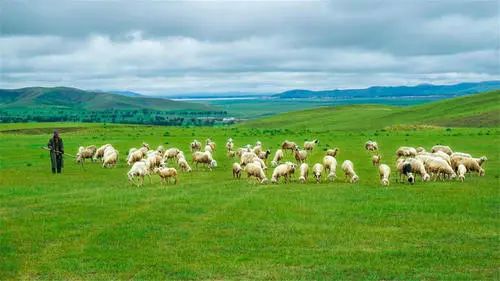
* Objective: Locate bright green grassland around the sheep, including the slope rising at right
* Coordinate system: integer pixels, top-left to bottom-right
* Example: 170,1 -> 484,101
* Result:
0,92 -> 500,280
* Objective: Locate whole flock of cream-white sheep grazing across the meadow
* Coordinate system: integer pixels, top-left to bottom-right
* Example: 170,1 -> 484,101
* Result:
76,138 -> 487,186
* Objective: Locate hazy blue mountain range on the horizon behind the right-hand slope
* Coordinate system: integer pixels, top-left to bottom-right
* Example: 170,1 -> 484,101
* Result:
272,81 -> 500,99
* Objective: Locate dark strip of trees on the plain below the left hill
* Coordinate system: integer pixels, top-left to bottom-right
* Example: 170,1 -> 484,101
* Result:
0,109 -> 238,126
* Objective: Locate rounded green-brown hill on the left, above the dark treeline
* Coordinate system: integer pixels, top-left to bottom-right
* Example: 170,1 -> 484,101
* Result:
0,87 -> 211,111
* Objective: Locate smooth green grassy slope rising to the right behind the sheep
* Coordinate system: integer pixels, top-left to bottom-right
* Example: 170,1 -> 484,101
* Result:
241,91 -> 500,131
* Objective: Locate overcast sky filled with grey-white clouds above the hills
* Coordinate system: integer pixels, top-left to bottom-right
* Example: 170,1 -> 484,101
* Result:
0,0 -> 500,95
